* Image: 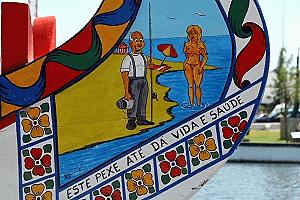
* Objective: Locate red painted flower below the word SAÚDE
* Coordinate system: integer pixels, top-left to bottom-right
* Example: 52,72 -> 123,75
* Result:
222,116 -> 247,142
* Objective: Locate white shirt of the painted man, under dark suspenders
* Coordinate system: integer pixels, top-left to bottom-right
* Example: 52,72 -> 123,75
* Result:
121,53 -> 147,77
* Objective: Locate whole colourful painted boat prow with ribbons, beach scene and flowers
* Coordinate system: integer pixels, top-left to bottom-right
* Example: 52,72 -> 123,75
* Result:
0,0 -> 269,200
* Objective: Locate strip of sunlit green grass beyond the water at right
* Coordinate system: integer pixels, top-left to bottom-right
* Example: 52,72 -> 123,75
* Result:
244,130 -> 286,143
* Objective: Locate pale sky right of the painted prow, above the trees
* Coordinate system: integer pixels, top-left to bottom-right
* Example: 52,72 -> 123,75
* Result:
259,0 -> 300,69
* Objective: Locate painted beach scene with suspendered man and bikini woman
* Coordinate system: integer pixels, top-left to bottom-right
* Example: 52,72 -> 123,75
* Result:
56,0 -> 233,184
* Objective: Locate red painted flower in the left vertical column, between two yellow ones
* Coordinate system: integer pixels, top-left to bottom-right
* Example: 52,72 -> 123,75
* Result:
24,148 -> 51,176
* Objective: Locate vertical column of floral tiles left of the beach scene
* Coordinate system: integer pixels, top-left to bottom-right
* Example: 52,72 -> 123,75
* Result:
16,97 -> 58,200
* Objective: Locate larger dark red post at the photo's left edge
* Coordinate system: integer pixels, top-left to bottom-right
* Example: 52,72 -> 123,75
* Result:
1,2 -> 33,74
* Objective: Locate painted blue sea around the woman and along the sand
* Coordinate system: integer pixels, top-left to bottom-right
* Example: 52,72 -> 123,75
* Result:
59,36 -> 232,185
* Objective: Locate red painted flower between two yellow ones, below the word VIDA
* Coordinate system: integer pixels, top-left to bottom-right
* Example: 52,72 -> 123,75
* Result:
159,150 -> 186,178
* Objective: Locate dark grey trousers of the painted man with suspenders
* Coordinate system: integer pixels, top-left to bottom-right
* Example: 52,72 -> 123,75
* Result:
127,78 -> 149,119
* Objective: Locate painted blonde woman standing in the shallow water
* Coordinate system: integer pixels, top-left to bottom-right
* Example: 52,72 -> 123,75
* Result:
183,25 -> 208,106
